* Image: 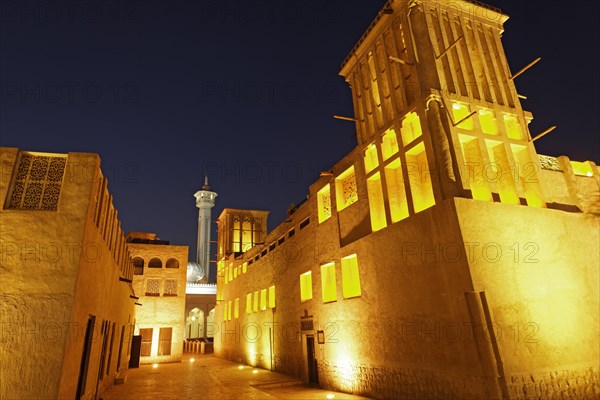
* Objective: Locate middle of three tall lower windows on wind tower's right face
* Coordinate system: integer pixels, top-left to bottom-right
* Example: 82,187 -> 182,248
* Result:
484,140 -> 520,204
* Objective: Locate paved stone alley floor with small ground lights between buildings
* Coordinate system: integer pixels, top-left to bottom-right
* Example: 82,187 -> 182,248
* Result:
104,354 -> 366,400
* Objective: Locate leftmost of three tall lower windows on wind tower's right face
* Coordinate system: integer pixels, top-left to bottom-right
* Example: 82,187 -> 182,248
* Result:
458,135 -> 493,201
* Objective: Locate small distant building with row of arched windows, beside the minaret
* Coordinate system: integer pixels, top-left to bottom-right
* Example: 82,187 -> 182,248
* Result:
127,232 -> 188,364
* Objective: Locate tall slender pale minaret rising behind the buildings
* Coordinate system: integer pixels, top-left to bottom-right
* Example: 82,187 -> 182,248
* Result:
194,176 -> 217,282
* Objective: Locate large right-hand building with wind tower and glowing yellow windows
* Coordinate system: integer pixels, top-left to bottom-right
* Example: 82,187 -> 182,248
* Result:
215,0 -> 600,399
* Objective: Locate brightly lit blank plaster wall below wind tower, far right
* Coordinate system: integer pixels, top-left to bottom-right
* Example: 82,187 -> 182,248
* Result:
455,199 -> 600,398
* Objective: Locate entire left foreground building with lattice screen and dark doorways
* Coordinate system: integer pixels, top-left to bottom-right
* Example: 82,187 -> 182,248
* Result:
0,147 -> 136,399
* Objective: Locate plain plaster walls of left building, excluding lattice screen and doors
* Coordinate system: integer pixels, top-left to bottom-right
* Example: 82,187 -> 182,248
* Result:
0,148 -> 132,399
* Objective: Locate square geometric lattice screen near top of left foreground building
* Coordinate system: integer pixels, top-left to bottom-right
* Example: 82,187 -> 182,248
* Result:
6,152 -> 67,211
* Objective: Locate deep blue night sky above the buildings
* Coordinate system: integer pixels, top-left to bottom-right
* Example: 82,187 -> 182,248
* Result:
0,0 -> 600,260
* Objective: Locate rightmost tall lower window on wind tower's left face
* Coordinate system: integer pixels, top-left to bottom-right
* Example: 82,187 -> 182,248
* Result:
406,142 -> 435,212
